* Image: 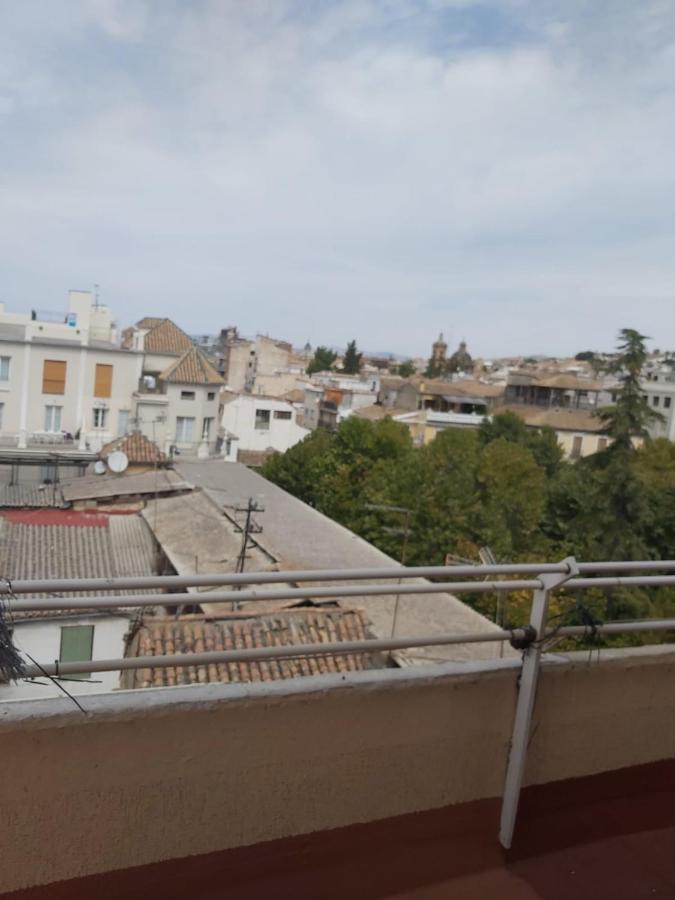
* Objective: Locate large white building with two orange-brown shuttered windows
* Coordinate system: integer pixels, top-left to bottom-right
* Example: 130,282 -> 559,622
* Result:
0,291 -> 142,449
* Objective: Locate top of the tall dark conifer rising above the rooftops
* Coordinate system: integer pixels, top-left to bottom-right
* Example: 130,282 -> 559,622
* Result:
599,328 -> 663,452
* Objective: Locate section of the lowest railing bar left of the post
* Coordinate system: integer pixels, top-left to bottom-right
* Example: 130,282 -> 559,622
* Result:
19,628 -> 525,678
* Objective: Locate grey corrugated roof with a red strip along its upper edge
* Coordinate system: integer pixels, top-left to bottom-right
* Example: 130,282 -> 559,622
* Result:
0,510 -> 157,619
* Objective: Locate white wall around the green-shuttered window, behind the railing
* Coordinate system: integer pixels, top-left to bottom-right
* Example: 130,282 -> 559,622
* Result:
0,615 -> 129,702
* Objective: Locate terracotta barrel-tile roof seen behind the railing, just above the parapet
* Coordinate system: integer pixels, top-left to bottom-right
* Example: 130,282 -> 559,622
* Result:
121,608 -> 386,688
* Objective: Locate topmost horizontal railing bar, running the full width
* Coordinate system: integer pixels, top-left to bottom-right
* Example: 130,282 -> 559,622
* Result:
5,560 -> 675,594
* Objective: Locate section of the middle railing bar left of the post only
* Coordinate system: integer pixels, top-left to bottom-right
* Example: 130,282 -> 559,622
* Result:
9,580 -> 540,615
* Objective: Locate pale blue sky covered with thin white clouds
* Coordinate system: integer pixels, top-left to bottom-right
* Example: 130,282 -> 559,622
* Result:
0,0 -> 675,357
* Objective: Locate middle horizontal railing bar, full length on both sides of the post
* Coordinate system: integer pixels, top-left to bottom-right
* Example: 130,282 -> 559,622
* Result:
10,575 -> 675,615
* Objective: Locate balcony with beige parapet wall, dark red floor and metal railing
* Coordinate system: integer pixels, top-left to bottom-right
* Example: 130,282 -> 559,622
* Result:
0,560 -> 675,900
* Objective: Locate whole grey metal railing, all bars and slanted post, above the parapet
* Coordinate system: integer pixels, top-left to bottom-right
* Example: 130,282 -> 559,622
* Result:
0,557 -> 675,848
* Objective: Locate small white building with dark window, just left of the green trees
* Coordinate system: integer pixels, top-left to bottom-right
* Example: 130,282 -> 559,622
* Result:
221,393 -> 309,453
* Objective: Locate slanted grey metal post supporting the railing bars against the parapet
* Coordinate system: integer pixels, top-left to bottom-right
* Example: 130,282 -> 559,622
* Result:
499,556 -> 579,850
